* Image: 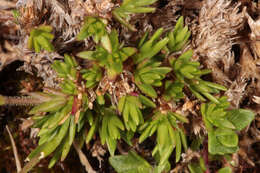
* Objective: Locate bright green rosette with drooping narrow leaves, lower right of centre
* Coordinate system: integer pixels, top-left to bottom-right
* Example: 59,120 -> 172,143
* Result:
139,111 -> 188,165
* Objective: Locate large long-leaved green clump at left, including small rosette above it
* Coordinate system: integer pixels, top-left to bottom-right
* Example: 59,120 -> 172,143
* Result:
23,55 -> 88,168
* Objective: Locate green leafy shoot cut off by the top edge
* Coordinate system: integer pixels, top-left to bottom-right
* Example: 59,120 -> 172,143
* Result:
112,0 -> 157,31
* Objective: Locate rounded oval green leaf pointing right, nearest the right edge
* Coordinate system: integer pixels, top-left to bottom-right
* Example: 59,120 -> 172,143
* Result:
227,109 -> 254,130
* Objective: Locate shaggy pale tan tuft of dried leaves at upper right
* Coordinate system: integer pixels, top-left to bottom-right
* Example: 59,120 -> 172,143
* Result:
194,0 -> 246,84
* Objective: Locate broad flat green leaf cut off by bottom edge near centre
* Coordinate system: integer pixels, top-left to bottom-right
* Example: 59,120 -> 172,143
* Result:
109,151 -> 152,173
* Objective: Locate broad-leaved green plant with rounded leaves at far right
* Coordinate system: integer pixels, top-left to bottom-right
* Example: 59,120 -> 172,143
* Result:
201,97 -> 254,155
